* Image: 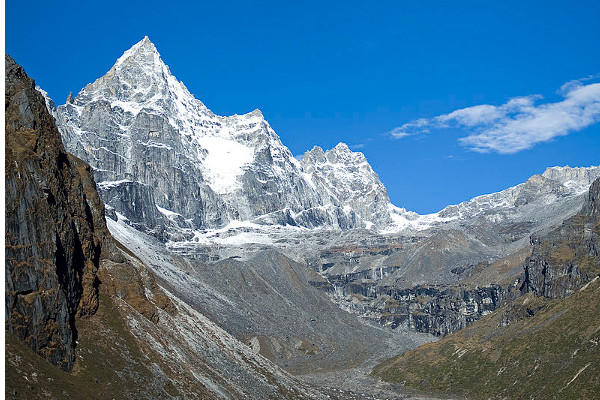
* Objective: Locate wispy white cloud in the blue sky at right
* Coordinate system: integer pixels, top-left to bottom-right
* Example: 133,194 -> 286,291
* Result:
390,76 -> 600,154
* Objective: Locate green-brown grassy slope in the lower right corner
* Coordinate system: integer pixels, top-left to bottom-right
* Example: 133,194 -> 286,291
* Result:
373,280 -> 600,399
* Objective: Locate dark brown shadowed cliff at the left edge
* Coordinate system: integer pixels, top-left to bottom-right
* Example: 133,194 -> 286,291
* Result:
5,55 -> 109,370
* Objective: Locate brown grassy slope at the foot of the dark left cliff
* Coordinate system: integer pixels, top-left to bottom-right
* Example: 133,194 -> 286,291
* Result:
5,293 -> 206,399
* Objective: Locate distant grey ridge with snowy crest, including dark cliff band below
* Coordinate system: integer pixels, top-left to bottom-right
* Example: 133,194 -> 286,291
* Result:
294,167 -> 600,336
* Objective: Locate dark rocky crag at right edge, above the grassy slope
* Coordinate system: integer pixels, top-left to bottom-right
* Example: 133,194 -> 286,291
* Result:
522,179 -> 600,298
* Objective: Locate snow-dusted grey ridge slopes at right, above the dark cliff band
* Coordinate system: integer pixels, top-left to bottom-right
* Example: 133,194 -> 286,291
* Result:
304,167 -> 600,287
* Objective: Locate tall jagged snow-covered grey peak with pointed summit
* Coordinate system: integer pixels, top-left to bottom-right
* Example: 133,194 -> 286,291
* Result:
49,37 -> 398,241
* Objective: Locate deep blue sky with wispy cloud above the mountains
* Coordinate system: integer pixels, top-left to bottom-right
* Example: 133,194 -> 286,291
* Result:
5,0 -> 600,213
